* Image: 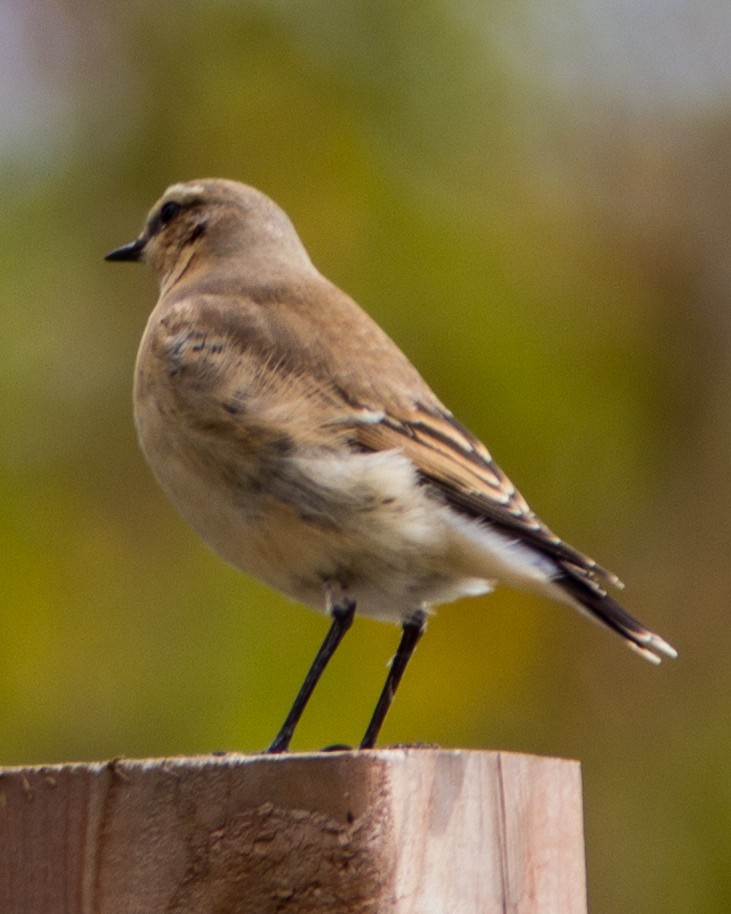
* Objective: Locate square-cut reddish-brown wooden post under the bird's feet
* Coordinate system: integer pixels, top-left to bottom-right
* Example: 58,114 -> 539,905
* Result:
0,748 -> 586,914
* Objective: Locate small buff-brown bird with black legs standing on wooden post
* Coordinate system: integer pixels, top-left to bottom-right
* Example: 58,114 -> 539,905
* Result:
106,178 -> 677,753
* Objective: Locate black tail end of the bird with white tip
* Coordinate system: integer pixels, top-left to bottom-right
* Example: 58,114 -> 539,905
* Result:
554,563 -> 678,663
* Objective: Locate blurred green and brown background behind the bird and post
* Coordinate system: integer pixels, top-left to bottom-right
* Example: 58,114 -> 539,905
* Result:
0,0 -> 731,914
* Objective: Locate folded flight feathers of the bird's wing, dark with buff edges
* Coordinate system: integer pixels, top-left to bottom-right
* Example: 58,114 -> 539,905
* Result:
352,403 -> 622,587
